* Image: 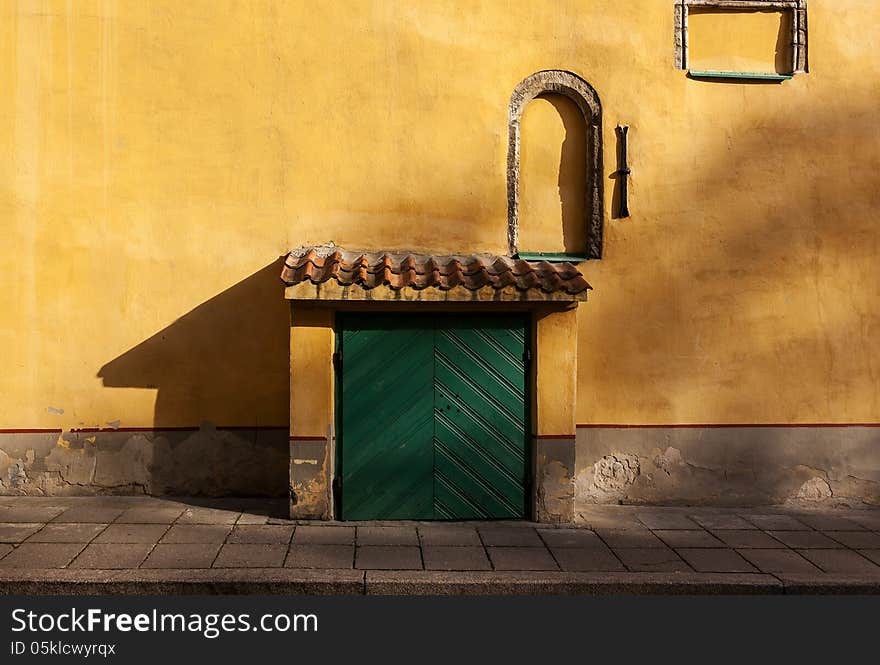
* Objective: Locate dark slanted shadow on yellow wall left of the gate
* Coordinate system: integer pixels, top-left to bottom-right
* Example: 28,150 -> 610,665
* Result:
98,259 -> 289,430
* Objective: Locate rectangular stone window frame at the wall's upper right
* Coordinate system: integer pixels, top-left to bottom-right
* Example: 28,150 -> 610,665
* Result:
675,0 -> 808,74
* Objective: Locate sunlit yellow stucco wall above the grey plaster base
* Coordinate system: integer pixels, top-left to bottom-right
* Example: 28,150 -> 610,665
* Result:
0,0 -> 880,428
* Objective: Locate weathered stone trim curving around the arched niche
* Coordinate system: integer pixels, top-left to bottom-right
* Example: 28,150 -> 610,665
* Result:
507,69 -> 604,259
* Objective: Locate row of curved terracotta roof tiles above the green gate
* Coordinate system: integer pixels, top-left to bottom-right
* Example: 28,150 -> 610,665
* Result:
281,246 -> 591,295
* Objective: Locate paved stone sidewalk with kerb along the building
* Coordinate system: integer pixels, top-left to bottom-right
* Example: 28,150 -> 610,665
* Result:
0,497 -> 880,595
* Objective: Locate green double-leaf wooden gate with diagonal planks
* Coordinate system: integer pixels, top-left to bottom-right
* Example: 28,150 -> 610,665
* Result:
336,313 -> 529,520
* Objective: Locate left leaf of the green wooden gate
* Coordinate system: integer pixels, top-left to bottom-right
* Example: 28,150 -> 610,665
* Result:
340,315 -> 434,520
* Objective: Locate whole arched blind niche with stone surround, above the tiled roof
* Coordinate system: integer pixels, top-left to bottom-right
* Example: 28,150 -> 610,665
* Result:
507,70 -> 602,259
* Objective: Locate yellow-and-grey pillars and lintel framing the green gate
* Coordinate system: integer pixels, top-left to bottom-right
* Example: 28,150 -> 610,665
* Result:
288,294 -> 580,523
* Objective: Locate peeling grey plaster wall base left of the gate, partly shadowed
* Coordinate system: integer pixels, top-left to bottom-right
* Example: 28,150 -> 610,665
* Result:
0,423 -> 288,496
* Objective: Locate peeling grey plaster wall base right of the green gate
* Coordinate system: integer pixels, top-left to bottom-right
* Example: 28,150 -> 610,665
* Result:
575,426 -> 880,512
